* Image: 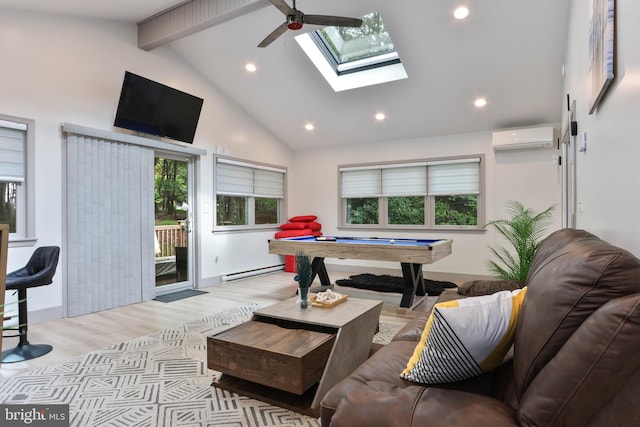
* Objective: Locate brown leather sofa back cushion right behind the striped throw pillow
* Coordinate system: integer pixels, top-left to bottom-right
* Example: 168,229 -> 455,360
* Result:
513,230 -> 640,400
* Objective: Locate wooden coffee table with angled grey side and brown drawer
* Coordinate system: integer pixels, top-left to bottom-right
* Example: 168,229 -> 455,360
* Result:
207,298 -> 382,417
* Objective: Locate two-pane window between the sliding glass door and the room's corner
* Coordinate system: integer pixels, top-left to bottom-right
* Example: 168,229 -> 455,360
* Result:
215,157 -> 286,230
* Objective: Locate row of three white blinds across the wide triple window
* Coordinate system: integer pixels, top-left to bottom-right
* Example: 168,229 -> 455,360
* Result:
340,157 -> 480,198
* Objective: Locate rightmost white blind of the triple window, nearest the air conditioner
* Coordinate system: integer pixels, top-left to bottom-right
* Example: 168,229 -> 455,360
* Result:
428,159 -> 480,196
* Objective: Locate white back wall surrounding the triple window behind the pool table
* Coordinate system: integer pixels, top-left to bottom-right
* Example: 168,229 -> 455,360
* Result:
291,132 -> 561,275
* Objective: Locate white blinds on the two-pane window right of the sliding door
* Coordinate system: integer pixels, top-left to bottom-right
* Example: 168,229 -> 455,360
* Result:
216,158 -> 285,198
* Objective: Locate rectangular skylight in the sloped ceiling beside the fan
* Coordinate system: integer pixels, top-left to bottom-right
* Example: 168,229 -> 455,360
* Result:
295,12 -> 407,92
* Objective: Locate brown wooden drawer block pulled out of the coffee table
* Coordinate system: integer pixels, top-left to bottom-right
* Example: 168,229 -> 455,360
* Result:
207,320 -> 335,395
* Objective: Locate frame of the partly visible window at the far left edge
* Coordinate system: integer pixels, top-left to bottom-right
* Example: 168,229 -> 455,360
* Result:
0,113 -> 37,247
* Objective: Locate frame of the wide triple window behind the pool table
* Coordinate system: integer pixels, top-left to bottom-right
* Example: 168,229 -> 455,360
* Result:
337,154 -> 486,232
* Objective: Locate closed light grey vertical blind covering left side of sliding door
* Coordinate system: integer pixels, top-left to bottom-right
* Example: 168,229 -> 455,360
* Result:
65,134 -> 155,316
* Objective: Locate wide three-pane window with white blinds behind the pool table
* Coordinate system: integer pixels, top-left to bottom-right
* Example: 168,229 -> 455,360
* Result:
339,156 -> 483,230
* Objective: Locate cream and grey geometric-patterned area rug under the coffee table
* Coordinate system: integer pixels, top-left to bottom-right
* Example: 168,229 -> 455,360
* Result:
0,304 -> 399,427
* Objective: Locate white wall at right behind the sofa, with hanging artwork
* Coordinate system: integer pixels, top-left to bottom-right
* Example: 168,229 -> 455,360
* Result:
563,0 -> 640,256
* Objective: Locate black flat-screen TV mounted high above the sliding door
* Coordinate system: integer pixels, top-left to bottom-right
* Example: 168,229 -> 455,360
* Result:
113,71 -> 202,143
